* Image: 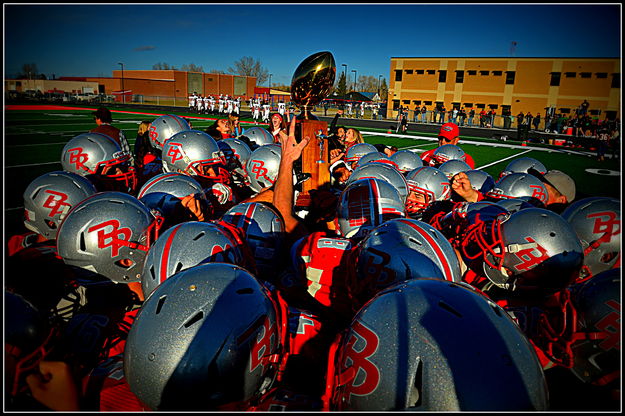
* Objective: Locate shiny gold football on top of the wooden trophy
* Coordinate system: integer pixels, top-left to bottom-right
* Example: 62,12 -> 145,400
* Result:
291,52 -> 336,118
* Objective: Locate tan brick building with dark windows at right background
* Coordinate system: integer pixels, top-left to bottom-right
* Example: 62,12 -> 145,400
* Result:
387,57 -> 621,120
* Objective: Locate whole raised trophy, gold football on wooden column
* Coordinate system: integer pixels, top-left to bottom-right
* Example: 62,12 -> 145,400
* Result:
291,52 -> 336,207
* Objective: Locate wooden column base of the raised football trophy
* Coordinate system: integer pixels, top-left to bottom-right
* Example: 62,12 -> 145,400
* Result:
295,120 -> 330,207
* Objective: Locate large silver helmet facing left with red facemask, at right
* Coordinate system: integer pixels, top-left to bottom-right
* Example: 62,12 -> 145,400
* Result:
461,208 -> 584,296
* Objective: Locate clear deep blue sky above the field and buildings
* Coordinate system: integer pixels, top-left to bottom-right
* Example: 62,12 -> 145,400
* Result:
4,3 -> 621,85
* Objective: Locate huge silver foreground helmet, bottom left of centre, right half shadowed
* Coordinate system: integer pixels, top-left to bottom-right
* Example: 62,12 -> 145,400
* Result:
124,263 -> 287,411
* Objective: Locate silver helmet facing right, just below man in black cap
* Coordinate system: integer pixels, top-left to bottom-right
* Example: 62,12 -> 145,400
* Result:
61,133 -> 138,192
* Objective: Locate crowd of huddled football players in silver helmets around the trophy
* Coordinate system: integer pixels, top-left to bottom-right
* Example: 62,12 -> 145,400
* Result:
5,106 -> 620,411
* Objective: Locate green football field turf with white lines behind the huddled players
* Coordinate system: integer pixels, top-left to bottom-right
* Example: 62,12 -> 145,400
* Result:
3,106 -> 621,241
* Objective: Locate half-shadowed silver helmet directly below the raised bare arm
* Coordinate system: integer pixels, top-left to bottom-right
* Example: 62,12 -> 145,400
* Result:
221,202 -> 286,281
